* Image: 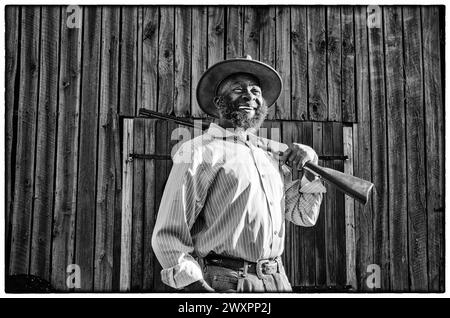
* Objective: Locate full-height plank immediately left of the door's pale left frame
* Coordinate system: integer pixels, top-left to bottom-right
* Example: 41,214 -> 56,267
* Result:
94,6 -> 120,292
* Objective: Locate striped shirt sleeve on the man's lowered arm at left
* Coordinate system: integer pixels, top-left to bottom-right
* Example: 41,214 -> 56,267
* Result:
152,143 -> 213,289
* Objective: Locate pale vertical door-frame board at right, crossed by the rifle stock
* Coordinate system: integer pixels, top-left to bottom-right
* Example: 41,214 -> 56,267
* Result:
342,124 -> 357,289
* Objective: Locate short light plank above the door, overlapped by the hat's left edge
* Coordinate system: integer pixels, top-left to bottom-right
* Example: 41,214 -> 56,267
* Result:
189,6 -> 208,117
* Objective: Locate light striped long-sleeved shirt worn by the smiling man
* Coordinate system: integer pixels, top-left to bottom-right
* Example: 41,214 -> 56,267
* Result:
152,124 -> 325,288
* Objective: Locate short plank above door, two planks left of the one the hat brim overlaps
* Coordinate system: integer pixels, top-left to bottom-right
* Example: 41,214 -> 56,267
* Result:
158,6 -> 175,114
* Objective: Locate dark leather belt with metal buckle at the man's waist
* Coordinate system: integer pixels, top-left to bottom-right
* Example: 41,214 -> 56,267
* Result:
204,254 -> 283,276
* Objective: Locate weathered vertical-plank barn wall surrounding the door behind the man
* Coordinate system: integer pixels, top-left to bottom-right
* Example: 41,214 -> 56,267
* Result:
5,6 -> 444,291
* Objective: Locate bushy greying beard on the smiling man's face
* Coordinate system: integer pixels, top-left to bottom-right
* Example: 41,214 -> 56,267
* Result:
217,96 -> 268,130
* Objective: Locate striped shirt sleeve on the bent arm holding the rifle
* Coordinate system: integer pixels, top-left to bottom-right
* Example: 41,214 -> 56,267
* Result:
285,165 -> 326,227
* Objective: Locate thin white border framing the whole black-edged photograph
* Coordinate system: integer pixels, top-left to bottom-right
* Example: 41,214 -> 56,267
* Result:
0,0 -> 450,302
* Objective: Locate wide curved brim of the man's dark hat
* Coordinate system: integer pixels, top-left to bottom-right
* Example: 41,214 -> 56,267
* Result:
197,58 -> 283,117
